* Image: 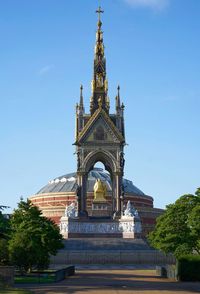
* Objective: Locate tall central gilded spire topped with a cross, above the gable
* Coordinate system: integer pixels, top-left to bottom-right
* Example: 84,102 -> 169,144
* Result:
90,7 -> 109,114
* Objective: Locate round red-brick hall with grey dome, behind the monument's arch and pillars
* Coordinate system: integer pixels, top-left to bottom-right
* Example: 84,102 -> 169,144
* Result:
30,168 -> 163,236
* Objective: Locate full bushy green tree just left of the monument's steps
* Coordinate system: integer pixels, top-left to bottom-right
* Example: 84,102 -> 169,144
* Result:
9,200 -> 63,272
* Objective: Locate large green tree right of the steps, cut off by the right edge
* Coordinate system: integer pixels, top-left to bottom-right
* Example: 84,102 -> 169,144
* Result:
148,189 -> 200,257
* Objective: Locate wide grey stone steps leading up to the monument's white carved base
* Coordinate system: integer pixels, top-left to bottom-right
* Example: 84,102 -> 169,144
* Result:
51,238 -> 175,266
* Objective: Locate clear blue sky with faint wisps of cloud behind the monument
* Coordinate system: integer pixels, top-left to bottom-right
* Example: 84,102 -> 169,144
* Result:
0,0 -> 200,209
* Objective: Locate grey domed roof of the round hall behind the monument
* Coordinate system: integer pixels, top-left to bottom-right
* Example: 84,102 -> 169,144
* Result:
36,168 -> 145,196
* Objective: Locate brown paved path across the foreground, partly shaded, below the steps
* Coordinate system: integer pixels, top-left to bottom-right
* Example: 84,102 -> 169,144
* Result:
16,269 -> 200,294
